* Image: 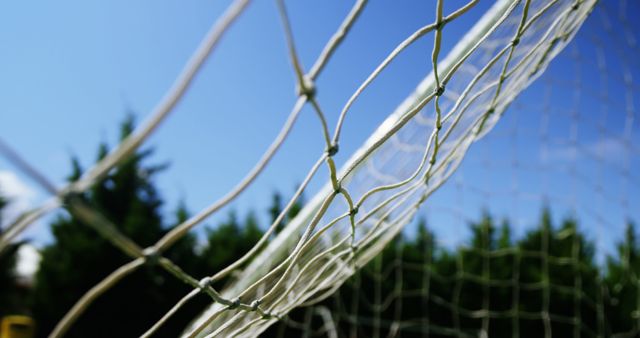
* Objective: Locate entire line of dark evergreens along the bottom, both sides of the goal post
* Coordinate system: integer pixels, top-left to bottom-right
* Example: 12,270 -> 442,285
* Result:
0,117 -> 640,337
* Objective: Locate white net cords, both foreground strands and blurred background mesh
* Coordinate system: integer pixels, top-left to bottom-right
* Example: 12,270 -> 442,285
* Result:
0,0 -> 637,336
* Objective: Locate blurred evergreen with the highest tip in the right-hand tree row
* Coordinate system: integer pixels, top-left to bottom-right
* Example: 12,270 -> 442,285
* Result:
519,208 -> 601,337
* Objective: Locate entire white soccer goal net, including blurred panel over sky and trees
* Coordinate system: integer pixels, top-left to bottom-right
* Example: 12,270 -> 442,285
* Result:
0,0 -> 640,337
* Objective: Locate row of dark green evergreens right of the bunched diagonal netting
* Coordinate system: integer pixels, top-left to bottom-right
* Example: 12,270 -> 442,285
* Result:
265,209 -> 640,337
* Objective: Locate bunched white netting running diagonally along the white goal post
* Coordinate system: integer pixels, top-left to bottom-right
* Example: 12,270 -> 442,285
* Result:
188,2 -> 592,335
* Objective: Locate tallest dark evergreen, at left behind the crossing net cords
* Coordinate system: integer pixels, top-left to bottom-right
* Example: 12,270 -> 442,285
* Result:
33,117 -> 195,337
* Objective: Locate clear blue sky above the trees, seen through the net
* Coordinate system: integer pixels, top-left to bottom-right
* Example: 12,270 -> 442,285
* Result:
0,0 -> 640,258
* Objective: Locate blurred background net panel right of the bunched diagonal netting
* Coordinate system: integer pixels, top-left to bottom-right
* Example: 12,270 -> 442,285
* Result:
268,2 -> 640,337
